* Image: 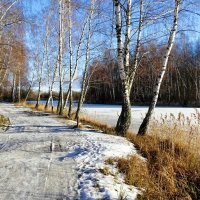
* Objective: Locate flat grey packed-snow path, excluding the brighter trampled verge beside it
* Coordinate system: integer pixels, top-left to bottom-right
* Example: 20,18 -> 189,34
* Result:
0,104 -> 77,199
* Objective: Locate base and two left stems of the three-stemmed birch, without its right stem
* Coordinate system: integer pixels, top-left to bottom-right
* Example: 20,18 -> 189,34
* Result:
113,0 -> 132,136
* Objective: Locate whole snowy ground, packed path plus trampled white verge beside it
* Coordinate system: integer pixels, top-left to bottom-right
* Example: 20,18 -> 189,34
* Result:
0,103 -> 141,200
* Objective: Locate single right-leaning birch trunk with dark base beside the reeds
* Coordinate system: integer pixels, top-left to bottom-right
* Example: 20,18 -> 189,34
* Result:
138,0 -> 182,135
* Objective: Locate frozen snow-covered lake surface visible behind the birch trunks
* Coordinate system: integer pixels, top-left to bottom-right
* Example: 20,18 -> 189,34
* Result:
82,104 -> 200,132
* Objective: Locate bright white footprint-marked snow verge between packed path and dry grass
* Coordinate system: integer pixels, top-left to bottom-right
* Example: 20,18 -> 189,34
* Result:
67,130 -> 139,200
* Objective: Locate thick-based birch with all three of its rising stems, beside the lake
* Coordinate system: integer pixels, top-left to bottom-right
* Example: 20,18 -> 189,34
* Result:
113,0 -> 143,136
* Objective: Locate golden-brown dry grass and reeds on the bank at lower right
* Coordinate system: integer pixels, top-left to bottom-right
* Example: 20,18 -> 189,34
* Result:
117,114 -> 200,200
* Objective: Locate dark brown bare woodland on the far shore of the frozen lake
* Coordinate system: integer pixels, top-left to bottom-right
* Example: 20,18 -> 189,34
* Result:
86,39 -> 200,106
